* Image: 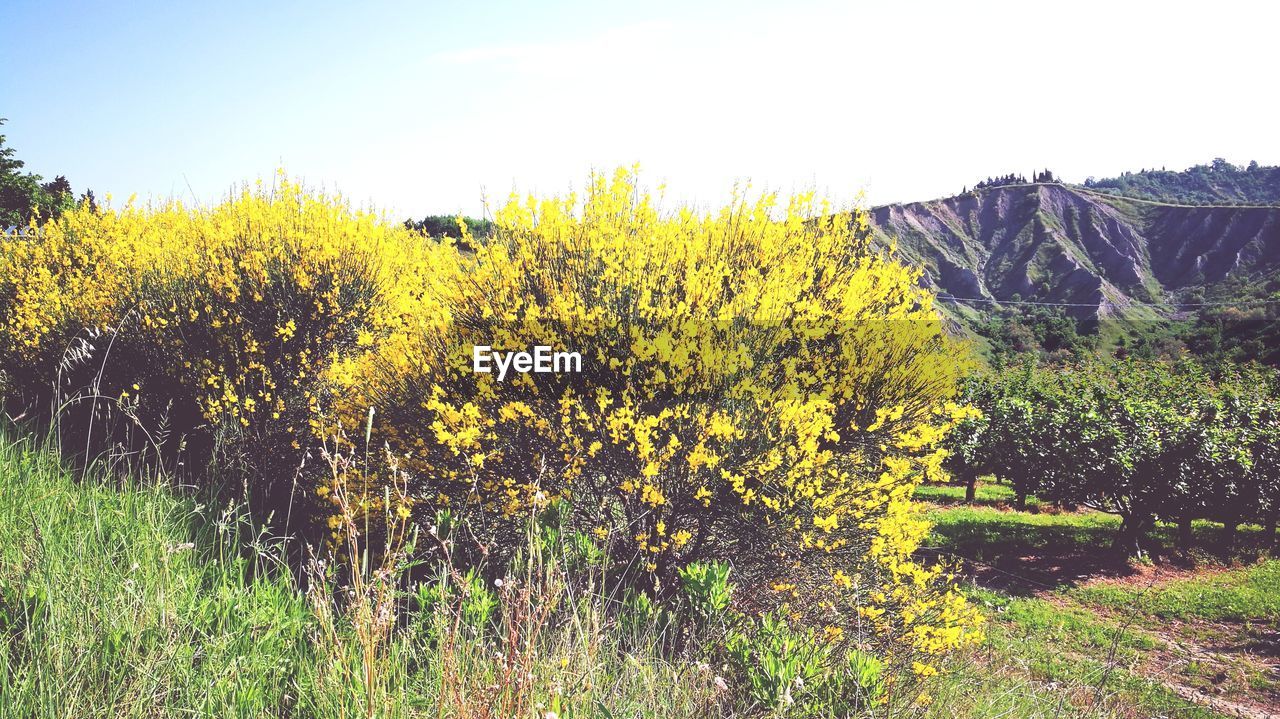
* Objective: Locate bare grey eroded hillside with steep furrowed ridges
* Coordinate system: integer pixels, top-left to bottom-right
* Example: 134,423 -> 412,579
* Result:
872,183 -> 1280,324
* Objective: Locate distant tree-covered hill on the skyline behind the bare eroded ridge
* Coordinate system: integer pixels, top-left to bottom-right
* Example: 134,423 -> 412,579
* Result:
1084,157 -> 1280,205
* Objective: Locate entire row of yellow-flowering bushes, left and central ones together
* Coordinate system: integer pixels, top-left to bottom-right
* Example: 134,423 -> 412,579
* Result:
0,171 -> 980,673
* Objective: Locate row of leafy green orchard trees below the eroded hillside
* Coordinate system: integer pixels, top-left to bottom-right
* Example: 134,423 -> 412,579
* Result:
948,358 -> 1280,549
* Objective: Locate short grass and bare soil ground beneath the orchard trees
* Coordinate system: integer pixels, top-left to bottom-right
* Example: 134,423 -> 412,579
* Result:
918,485 -> 1280,718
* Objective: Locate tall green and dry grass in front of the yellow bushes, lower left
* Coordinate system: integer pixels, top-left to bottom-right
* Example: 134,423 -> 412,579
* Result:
0,427 -> 735,719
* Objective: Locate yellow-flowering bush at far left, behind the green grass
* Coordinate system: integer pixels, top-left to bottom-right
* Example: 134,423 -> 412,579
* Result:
0,177 -> 440,516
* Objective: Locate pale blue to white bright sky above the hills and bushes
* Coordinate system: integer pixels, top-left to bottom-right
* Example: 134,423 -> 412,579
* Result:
0,0 -> 1280,217
